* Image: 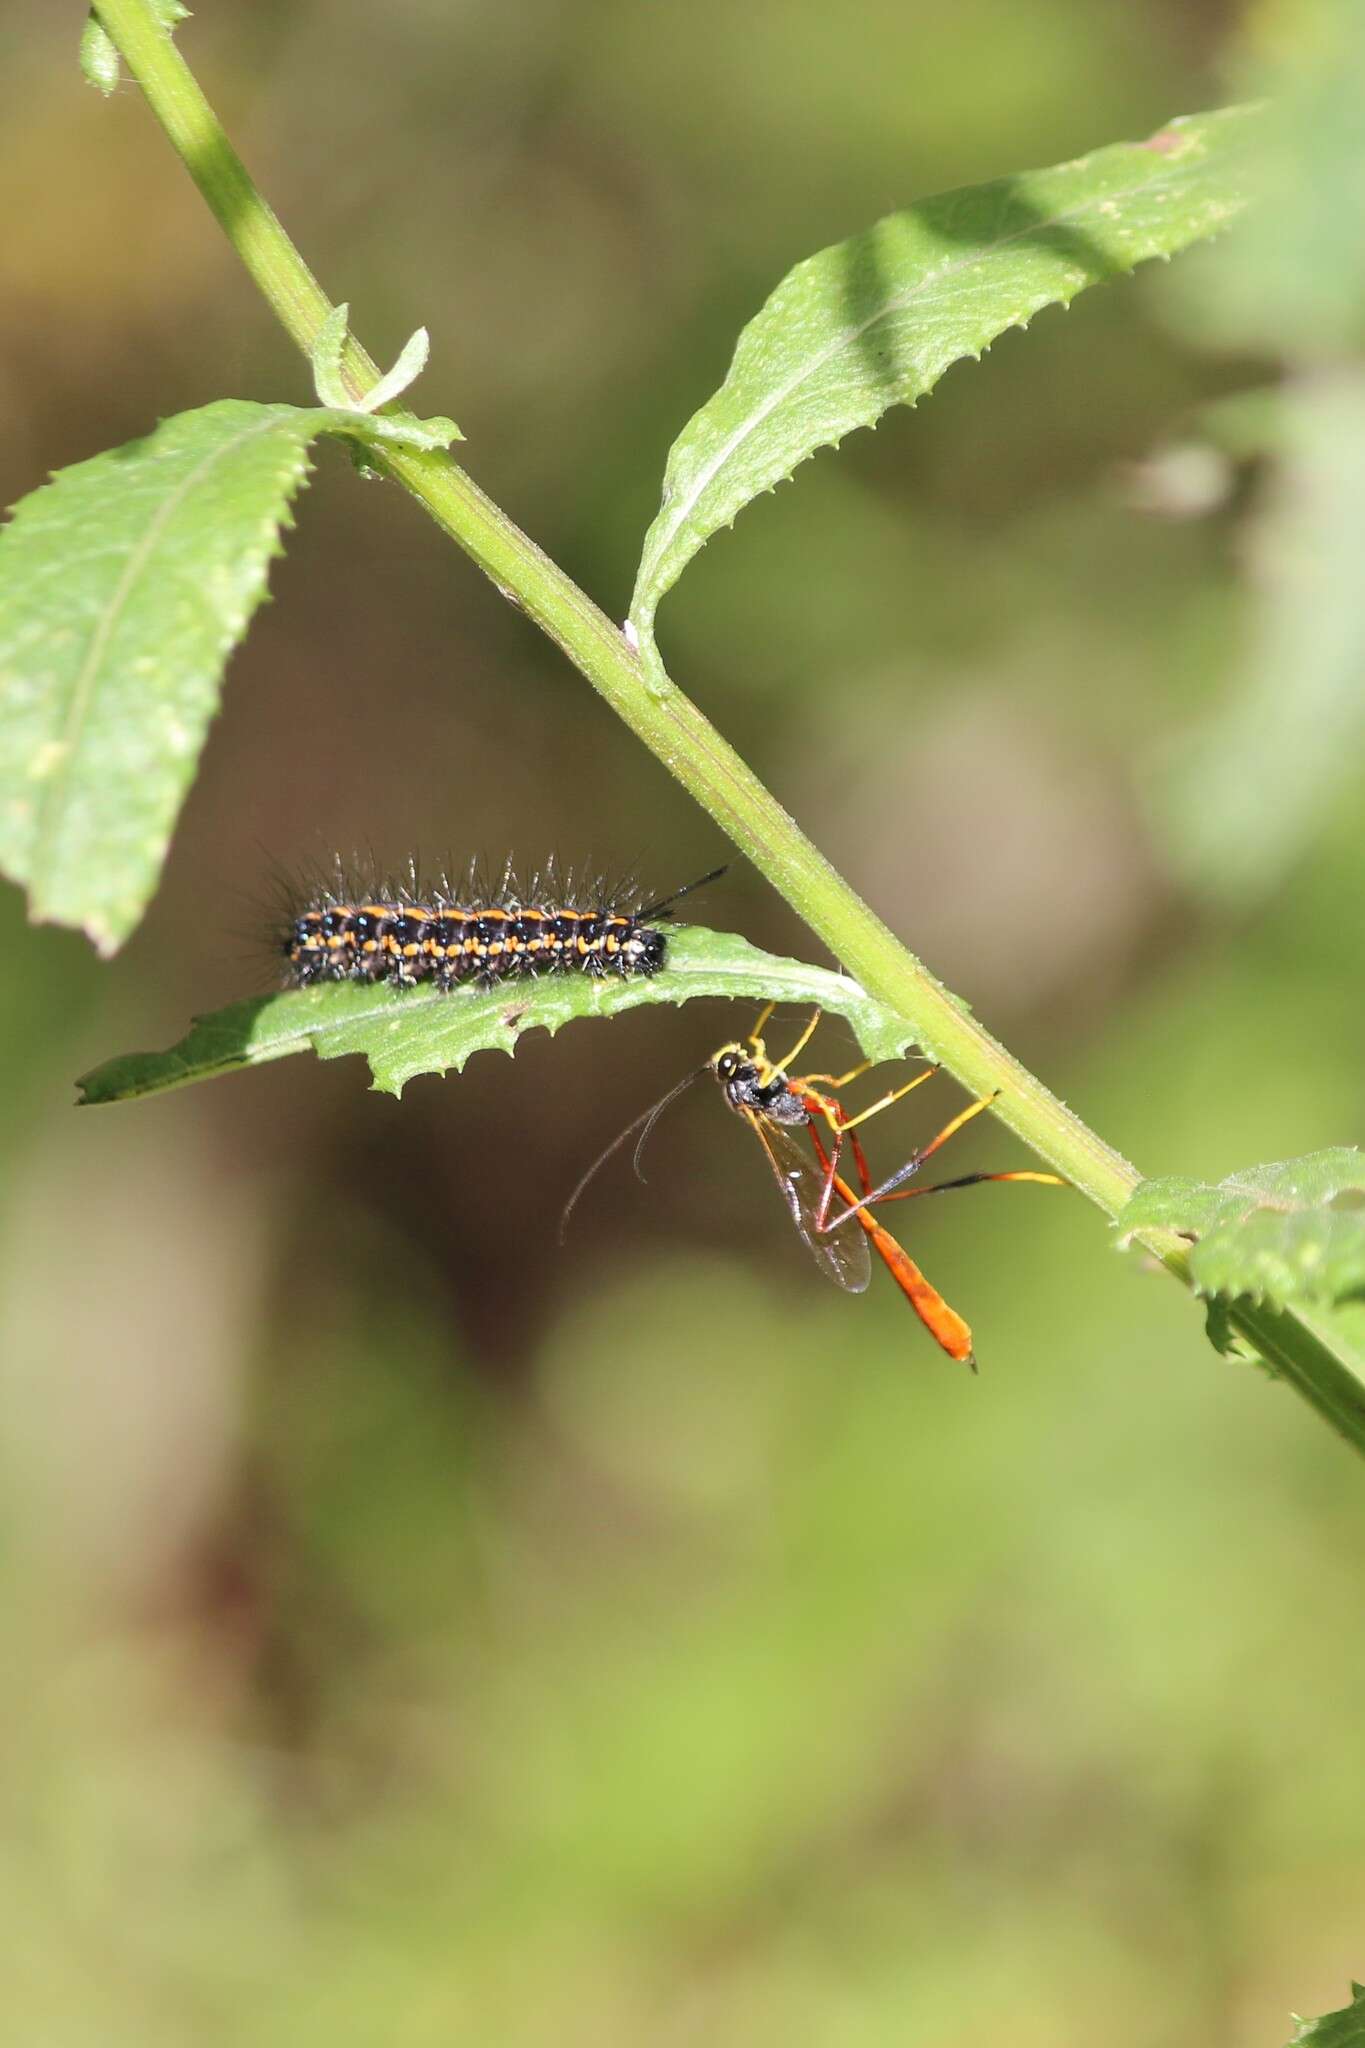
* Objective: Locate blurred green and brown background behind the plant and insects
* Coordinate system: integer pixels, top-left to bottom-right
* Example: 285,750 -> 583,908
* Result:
0,0 -> 1365,2048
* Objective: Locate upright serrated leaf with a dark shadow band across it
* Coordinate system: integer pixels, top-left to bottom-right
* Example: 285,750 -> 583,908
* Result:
630,109 -> 1257,649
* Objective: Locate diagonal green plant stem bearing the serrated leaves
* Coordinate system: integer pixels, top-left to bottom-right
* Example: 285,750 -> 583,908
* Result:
87,0 -> 1365,1450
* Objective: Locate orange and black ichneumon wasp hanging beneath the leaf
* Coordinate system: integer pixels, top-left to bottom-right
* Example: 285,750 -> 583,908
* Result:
559,1004 -> 1066,1370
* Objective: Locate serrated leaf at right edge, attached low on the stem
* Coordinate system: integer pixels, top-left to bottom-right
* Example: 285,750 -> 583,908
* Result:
1117,1145 -> 1365,1310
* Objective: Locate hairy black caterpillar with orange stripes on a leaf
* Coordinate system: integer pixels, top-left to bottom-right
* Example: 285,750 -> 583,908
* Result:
280,866 -> 724,989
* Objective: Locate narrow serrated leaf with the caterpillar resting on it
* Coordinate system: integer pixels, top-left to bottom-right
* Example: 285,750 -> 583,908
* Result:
78,926 -> 911,1104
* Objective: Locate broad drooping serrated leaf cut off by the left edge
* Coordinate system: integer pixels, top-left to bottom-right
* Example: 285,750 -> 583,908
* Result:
0,399 -> 417,952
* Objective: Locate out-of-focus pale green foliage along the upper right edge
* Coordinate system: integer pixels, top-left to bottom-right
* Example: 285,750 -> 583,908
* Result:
1152,4 -> 1365,903
